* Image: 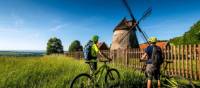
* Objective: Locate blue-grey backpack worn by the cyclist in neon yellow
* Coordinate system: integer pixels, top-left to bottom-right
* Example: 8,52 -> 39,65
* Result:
83,40 -> 93,60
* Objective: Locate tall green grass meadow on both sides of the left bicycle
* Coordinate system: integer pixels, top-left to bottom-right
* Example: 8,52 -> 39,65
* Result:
0,55 -> 199,88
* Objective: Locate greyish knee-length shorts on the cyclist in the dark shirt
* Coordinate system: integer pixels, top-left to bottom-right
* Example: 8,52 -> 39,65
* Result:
145,64 -> 160,80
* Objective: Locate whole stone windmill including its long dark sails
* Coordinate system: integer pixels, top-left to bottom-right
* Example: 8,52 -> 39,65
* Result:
110,0 -> 152,50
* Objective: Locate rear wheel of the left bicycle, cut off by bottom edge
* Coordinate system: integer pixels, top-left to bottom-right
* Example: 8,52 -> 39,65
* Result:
70,73 -> 94,88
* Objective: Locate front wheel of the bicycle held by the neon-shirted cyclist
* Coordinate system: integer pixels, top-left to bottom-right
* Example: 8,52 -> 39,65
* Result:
105,69 -> 120,87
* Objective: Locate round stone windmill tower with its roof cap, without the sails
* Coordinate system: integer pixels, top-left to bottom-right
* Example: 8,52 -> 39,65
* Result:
110,18 -> 139,50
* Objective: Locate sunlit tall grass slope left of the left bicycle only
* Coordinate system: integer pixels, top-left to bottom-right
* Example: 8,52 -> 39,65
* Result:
0,56 -> 87,88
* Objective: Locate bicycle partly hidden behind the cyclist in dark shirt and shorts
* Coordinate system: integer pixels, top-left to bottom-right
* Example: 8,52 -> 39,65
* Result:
140,60 -> 195,88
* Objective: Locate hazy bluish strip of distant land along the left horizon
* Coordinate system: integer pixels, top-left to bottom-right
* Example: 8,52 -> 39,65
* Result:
0,50 -> 45,56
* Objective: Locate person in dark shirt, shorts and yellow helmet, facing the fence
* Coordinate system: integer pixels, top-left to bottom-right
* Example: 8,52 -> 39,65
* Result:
141,37 -> 162,88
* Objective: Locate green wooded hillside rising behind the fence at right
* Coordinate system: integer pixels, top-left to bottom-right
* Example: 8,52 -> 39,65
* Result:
170,21 -> 200,45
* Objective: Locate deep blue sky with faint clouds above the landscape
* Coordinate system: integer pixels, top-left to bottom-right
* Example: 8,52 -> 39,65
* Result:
0,0 -> 200,50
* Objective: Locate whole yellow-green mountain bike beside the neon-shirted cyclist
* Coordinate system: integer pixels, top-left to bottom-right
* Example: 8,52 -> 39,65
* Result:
70,60 -> 120,88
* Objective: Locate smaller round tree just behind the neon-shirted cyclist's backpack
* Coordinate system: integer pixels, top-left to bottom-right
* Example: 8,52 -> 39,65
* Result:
69,40 -> 83,52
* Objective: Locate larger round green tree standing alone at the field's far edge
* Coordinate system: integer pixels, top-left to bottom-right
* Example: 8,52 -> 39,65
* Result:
47,37 -> 64,55
